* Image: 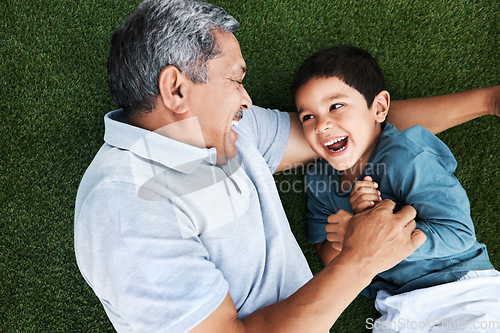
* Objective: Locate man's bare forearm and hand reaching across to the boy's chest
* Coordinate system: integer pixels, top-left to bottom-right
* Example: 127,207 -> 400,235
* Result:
192,200 -> 426,333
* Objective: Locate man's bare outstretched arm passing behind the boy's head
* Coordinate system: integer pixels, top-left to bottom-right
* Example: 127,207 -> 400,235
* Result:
275,86 -> 500,172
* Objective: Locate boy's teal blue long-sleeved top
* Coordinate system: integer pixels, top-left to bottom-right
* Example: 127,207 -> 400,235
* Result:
306,124 -> 493,297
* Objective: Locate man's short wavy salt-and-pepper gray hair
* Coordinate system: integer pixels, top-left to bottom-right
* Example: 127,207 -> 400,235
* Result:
107,0 -> 239,114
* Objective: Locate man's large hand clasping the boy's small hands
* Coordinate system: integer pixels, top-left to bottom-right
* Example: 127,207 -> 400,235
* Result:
342,199 -> 427,275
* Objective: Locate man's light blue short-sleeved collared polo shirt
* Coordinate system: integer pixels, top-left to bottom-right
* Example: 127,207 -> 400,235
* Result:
75,106 -> 312,332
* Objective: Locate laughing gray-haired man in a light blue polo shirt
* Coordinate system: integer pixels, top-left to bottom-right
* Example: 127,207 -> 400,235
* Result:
75,0 -> 498,332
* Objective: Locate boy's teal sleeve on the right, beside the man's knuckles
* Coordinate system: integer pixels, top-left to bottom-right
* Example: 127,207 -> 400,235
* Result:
390,151 -> 476,261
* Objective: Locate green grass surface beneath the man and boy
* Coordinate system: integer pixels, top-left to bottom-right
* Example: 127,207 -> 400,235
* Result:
0,0 -> 500,332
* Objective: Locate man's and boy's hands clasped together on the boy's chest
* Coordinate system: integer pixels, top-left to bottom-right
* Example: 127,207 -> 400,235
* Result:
325,176 -> 426,272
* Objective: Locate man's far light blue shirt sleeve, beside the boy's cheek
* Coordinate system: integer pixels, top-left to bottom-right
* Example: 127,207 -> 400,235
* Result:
238,106 -> 290,173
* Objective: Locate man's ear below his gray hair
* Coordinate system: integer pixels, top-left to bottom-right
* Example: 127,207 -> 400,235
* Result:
159,66 -> 187,114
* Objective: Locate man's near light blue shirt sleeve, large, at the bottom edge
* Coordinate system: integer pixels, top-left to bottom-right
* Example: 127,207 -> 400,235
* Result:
75,182 -> 228,332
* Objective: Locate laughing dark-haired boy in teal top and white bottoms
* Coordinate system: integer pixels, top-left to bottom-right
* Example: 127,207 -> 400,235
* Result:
292,46 -> 500,332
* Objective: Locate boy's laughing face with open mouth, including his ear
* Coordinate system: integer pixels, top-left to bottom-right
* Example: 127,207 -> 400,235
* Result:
295,77 -> 389,171
